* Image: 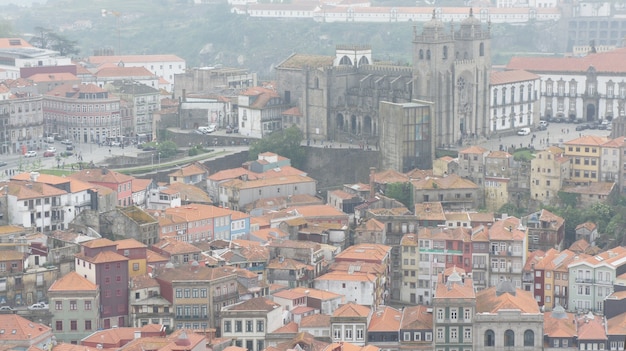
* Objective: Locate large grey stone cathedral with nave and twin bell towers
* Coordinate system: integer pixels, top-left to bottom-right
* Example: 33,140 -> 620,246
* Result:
275,9 -> 491,171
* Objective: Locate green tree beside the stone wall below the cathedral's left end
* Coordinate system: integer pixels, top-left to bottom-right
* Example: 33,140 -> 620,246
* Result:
248,126 -> 306,168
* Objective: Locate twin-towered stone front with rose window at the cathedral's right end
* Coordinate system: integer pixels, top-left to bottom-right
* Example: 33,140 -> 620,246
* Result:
413,9 -> 491,147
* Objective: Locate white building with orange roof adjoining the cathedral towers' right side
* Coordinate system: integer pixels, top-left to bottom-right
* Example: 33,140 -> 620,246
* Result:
489,70 -> 539,133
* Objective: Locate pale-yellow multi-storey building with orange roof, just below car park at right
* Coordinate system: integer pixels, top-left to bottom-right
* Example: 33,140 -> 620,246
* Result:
565,135 -> 609,183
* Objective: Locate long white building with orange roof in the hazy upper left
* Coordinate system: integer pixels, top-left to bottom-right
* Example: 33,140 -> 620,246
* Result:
88,55 -> 187,91
